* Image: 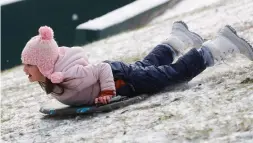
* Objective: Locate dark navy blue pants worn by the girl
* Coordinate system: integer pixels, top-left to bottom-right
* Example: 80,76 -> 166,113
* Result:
107,44 -> 207,96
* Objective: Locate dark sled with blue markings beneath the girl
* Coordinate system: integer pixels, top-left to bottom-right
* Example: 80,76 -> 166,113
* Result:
40,94 -> 148,116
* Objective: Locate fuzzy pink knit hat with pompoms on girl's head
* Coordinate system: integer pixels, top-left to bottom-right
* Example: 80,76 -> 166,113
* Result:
21,26 -> 63,83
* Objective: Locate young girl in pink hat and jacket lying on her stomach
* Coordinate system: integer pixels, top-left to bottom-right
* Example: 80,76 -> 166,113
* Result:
21,21 -> 253,105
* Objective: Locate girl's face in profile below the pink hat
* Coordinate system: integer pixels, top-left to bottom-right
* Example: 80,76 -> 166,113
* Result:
24,64 -> 46,82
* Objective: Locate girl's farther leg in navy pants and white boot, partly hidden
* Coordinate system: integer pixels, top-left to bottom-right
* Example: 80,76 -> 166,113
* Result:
135,21 -> 203,67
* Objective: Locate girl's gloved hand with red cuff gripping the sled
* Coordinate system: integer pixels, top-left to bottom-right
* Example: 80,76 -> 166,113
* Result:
95,90 -> 116,104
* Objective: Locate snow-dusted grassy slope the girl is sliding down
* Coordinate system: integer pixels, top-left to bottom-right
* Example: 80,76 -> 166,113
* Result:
1,0 -> 253,143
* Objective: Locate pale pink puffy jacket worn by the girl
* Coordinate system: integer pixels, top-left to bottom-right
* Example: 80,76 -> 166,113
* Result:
52,47 -> 115,105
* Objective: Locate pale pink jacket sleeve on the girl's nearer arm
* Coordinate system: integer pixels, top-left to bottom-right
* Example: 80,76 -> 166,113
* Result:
64,63 -> 115,91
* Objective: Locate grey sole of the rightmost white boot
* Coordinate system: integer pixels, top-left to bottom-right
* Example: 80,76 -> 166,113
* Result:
225,25 -> 253,61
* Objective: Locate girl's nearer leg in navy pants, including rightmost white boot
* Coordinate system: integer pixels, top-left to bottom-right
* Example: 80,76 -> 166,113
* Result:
111,26 -> 253,96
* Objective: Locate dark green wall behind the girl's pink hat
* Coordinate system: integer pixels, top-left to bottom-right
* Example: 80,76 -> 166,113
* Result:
1,0 -> 134,70
